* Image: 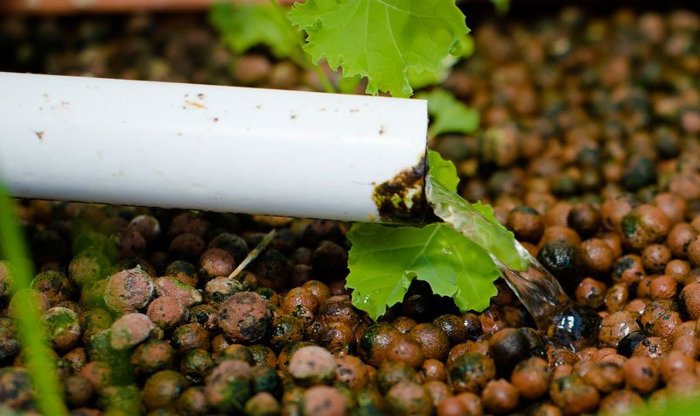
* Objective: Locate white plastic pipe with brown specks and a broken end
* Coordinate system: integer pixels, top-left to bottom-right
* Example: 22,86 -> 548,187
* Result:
0,73 -> 428,221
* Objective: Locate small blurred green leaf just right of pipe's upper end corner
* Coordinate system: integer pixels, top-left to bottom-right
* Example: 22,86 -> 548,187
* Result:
418,89 -> 479,137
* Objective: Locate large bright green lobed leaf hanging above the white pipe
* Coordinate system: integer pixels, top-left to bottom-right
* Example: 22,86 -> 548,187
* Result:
288,0 -> 468,97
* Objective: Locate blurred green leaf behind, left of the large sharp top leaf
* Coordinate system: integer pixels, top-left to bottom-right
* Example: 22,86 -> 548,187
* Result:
209,3 -> 300,58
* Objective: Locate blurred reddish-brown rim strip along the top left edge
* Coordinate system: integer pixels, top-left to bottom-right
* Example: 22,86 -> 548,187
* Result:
0,0 -> 268,14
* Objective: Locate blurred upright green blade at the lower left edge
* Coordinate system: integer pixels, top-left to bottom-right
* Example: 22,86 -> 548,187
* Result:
0,185 -> 68,416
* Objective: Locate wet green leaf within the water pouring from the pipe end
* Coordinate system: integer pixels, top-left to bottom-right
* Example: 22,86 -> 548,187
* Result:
425,172 -> 529,271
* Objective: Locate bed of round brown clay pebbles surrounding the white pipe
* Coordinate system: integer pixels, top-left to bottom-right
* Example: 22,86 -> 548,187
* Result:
0,4 -> 700,416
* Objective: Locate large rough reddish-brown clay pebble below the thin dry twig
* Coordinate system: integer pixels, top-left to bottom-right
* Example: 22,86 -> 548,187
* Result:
218,292 -> 272,343
